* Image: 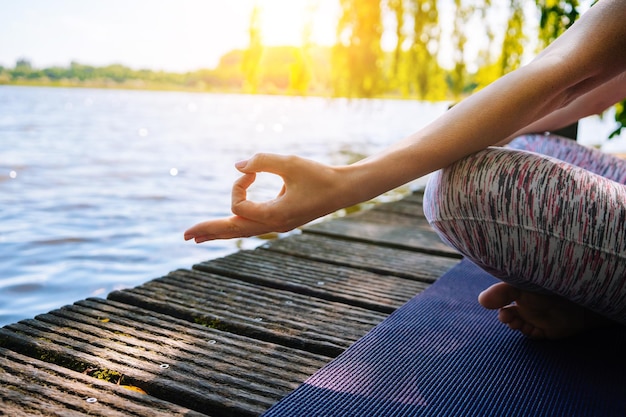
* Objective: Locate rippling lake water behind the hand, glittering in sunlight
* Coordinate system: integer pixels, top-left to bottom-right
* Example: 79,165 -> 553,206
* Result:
0,86 -> 446,325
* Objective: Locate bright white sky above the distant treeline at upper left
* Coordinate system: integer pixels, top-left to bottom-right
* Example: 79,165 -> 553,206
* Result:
0,0 -> 339,72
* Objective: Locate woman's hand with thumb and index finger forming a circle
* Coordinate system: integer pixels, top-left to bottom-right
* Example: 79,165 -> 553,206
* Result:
185,154 -> 347,243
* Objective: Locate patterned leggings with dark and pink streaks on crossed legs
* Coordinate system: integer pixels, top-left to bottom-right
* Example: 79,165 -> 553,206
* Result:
424,135 -> 626,324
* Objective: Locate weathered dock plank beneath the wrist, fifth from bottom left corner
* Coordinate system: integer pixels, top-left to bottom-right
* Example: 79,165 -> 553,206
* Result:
260,233 -> 458,283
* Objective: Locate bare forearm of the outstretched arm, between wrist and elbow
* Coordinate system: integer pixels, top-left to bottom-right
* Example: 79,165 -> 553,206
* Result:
346,62 -> 596,203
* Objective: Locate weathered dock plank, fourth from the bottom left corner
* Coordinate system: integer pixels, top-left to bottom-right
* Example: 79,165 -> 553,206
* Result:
194,250 -> 428,314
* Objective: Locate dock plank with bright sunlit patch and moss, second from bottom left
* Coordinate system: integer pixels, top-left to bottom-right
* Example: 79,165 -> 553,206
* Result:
0,299 -> 327,416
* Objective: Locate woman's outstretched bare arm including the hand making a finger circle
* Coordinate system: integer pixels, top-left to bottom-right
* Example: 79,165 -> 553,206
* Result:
185,0 -> 626,242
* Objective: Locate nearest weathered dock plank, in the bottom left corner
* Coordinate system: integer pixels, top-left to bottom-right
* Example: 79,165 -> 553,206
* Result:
0,348 -> 209,417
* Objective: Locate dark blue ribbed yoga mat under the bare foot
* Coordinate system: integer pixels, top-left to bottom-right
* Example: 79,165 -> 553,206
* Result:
264,260 -> 626,417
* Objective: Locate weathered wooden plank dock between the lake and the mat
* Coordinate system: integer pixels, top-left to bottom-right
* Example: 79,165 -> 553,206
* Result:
0,192 -> 460,417
